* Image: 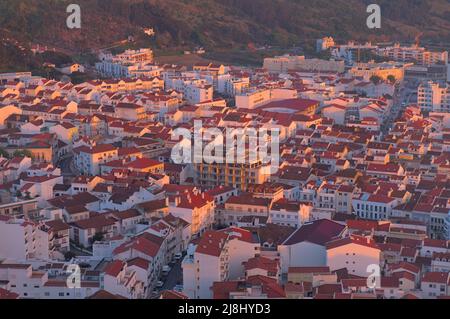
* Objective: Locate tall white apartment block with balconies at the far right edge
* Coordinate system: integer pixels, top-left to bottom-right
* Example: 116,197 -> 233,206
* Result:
417,81 -> 450,113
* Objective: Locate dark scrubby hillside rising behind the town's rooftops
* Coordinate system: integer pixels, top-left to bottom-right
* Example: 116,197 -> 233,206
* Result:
0,0 -> 450,67
